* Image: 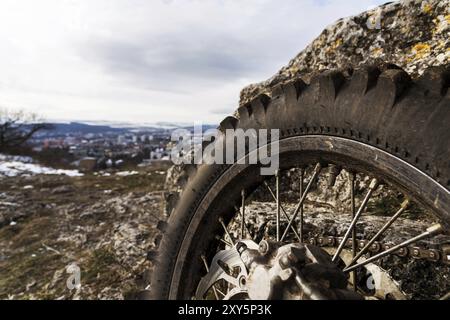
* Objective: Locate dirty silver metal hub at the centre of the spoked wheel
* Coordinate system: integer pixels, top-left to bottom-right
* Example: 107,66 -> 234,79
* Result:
196,240 -> 362,300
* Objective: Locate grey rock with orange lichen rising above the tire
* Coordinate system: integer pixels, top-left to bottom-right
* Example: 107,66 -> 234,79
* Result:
240,0 -> 450,105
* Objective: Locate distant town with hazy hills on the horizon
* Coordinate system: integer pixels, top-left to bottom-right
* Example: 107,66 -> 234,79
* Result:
28,122 -> 216,171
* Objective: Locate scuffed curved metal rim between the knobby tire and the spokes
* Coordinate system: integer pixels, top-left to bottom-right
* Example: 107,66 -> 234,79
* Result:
170,135 -> 450,298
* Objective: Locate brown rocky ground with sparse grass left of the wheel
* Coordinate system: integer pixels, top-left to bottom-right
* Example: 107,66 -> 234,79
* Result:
0,167 -> 167,299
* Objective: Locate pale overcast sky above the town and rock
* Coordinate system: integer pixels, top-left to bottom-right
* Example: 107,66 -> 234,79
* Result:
0,0 -> 385,123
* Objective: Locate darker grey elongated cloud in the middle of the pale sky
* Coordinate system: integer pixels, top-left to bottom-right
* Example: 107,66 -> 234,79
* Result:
81,34 -> 256,92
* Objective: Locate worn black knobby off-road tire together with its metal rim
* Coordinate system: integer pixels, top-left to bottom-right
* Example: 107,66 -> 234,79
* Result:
149,65 -> 450,299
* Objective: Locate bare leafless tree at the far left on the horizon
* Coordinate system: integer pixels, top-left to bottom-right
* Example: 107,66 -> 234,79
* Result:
0,108 -> 51,151
